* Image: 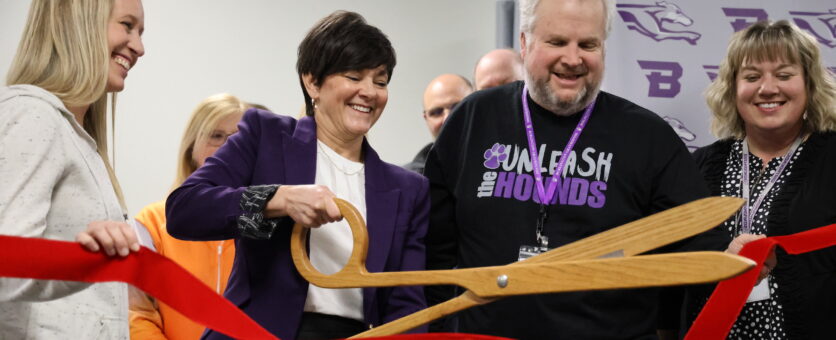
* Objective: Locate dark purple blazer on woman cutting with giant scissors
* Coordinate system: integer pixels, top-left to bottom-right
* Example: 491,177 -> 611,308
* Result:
166,109 -> 429,339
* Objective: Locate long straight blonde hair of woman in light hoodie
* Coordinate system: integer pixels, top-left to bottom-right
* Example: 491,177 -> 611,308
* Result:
6,0 -> 125,210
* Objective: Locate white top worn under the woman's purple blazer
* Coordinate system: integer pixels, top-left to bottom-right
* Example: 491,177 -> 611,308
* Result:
305,140 -> 366,322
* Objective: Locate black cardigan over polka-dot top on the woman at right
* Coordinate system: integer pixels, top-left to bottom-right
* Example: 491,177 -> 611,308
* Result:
689,132 -> 836,339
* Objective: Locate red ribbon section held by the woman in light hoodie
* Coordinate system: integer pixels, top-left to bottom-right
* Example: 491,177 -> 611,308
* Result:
0,235 -> 504,340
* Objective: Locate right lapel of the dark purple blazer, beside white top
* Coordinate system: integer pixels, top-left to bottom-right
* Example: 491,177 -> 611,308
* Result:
363,140 -> 400,316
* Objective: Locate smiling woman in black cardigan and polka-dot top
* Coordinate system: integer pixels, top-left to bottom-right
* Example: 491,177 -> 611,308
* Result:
688,20 -> 836,339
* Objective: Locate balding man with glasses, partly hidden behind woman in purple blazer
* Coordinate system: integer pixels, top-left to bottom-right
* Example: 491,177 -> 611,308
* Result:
404,73 -> 473,173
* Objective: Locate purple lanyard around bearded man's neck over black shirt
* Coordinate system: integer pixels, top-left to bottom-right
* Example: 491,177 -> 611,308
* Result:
522,84 -> 595,205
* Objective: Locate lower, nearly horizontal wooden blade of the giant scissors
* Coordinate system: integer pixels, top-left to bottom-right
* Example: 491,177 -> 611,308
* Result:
471,251 -> 755,298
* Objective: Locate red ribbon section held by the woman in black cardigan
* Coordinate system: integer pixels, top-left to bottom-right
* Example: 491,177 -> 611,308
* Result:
685,224 -> 836,340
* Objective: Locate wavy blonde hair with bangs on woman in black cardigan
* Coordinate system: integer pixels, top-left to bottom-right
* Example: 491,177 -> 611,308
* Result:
705,20 -> 836,139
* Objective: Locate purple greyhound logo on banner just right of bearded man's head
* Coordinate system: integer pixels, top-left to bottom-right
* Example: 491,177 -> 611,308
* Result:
616,1 -> 702,45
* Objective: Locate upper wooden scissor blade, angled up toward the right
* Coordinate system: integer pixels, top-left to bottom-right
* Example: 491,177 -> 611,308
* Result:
524,197 -> 743,265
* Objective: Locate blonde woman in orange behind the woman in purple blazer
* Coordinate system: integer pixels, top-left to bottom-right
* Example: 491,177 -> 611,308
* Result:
130,94 -> 252,340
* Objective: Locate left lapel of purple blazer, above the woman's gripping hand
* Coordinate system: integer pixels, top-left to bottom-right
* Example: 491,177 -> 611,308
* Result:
282,117 -> 316,184
